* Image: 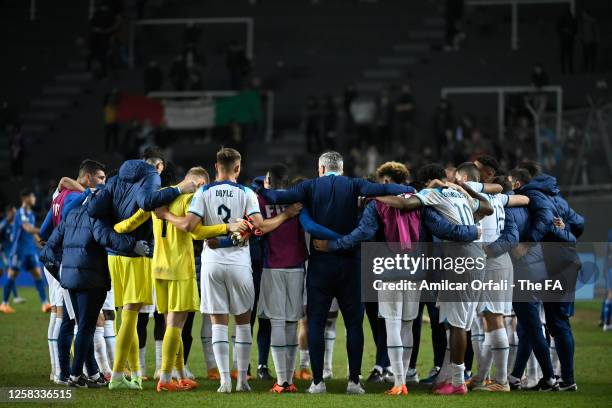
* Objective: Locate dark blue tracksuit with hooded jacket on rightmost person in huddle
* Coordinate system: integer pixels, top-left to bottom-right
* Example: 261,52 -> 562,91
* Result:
518,174 -> 584,384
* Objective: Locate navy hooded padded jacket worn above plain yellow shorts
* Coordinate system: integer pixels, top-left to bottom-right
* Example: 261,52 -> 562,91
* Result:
87,160 -> 180,257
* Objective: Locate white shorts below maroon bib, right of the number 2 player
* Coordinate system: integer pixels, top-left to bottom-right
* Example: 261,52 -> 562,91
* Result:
257,268 -> 304,322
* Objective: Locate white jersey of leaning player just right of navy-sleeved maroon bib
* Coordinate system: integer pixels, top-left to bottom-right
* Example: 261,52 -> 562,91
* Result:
415,188 -> 480,225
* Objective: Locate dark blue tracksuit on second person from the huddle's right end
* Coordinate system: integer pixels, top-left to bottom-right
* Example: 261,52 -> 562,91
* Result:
487,207 -> 554,380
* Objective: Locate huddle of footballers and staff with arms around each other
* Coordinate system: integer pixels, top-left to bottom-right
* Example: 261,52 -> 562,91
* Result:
0,148 -> 584,395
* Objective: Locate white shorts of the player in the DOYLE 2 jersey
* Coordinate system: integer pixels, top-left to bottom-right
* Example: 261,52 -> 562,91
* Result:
200,262 -> 255,316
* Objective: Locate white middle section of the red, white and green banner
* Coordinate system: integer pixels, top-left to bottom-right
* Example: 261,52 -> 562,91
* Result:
164,100 -> 215,129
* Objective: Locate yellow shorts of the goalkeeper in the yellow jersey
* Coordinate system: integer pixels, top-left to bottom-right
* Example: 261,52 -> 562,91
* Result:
155,278 -> 200,314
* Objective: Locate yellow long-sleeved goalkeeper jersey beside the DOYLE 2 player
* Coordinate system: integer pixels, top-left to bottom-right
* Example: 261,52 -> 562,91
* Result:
114,194 -> 227,280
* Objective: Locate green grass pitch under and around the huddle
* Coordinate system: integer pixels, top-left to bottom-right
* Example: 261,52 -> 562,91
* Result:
0,288 -> 612,408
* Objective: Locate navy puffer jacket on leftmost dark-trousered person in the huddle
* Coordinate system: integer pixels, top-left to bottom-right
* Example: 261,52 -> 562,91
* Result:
40,205 -> 136,290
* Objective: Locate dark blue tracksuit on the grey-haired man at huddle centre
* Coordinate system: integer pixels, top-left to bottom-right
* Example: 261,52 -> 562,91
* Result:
260,174 -> 413,384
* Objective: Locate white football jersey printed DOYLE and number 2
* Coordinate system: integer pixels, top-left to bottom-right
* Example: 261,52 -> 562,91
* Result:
189,181 -> 260,266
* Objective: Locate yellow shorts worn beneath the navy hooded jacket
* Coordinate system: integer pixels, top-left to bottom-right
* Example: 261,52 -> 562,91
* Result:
108,255 -> 153,307
